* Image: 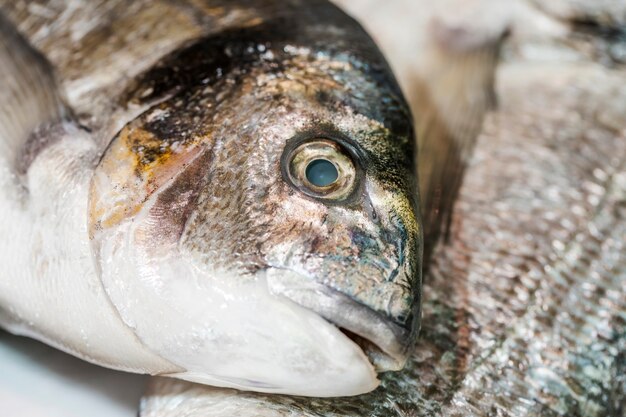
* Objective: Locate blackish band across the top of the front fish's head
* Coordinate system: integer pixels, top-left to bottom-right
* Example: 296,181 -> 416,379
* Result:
121,1 -> 413,136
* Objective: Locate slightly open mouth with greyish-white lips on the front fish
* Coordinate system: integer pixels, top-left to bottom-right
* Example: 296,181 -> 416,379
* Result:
267,269 -> 411,372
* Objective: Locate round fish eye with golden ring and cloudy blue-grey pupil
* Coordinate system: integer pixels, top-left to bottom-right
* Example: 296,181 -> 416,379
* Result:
287,138 -> 357,201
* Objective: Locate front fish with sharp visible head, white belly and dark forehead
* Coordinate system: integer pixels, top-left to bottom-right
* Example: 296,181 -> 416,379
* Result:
0,0 -> 423,397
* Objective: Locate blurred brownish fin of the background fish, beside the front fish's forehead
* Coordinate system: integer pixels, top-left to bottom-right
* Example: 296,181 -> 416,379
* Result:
411,18 -> 507,264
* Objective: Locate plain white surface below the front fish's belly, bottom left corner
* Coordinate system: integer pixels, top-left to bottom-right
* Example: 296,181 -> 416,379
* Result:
0,330 -> 147,417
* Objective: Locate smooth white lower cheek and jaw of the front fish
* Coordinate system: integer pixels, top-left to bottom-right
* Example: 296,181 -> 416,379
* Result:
92,200 -> 379,397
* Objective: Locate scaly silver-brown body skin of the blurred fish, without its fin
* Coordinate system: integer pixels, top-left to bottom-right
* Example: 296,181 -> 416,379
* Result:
141,2 -> 626,417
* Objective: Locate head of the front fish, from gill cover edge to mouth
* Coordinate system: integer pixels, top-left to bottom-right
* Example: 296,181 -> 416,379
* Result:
90,38 -> 421,396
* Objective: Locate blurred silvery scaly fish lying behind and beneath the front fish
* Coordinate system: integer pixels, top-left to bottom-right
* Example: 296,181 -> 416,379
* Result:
140,0 -> 626,417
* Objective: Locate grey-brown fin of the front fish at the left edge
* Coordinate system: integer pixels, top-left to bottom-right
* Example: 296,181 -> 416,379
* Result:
0,12 -> 71,171
